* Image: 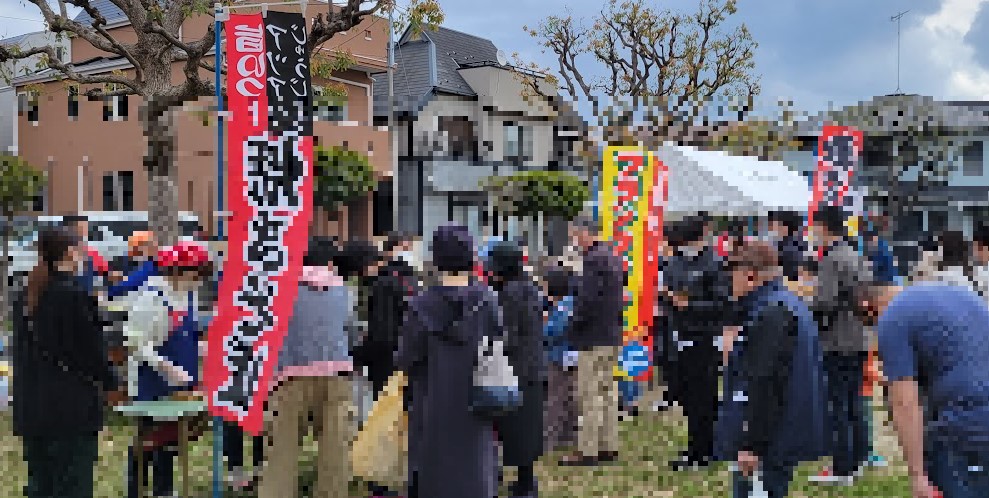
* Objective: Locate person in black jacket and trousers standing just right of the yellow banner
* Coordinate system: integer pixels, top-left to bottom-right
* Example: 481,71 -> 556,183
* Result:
663,219 -> 734,469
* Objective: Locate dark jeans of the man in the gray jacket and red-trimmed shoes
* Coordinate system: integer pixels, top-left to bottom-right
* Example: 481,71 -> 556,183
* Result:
824,352 -> 869,476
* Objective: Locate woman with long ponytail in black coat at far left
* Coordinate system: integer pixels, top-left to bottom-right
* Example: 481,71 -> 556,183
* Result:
12,228 -> 117,498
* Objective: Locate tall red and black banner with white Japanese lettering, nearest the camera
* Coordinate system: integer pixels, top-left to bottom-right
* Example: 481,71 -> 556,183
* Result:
204,12 -> 313,433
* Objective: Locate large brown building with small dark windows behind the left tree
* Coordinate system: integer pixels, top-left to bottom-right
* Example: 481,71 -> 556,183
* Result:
12,0 -> 392,236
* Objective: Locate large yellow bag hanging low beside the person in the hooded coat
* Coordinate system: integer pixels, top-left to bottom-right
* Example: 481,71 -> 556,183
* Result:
350,372 -> 409,489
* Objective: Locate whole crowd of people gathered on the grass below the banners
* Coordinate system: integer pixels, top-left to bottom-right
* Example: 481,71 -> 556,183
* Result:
12,207 -> 989,498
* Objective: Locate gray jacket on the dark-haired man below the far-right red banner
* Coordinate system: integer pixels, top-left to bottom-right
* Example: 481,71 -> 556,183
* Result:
811,240 -> 872,353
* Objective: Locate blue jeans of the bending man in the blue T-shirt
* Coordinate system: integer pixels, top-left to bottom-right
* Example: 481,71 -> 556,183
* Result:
926,443 -> 989,498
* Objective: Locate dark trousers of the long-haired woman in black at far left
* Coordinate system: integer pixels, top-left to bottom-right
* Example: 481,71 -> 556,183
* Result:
23,434 -> 99,498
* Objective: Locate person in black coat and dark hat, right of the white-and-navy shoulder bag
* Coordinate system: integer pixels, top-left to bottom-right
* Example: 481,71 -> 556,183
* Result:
488,242 -> 546,497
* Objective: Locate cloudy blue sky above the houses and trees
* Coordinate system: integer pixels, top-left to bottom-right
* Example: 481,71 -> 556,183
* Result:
7,0 -> 989,111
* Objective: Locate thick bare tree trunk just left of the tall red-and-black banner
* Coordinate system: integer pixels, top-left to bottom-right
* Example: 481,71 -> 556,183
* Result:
141,102 -> 179,245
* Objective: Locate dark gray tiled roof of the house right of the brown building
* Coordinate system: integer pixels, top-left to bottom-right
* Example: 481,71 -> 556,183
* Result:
374,27 -> 506,116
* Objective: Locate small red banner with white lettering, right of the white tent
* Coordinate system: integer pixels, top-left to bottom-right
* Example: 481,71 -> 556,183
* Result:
807,126 -> 863,256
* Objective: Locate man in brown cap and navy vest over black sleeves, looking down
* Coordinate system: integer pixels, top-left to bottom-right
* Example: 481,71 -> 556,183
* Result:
715,241 -> 827,498
